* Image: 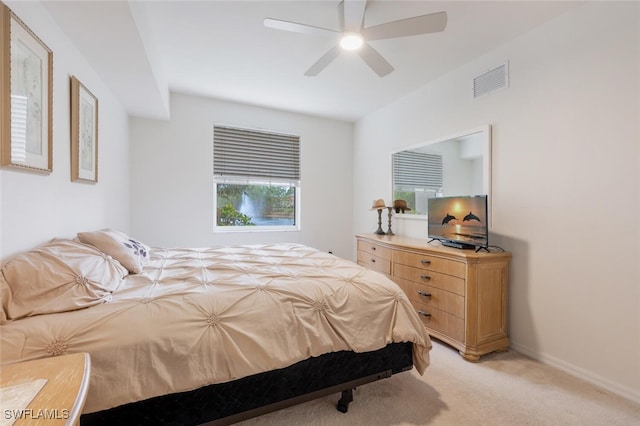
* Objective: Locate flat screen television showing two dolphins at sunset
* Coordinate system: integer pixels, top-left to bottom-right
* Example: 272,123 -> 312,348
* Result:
427,195 -> 489,251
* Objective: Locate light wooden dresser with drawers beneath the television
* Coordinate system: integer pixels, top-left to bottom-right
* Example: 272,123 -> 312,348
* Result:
356,234 -> 511,361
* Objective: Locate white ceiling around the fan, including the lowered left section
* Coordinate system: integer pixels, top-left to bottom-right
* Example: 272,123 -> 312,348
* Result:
43,0 -> 579,121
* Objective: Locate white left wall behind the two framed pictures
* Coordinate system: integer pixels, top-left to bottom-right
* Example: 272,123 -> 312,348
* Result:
0,1 -> 129,259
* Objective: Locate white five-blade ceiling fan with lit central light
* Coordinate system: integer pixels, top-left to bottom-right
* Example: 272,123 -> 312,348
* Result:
264,0 -> 447,77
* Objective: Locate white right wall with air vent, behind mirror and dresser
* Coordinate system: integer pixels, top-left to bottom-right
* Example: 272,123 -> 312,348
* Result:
354,2 -> 640,402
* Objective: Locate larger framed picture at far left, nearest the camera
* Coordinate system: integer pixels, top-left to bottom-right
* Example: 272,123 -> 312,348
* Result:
0,3 -> 53,173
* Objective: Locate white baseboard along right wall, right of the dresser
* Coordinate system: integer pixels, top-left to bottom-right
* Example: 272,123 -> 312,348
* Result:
510,341 -> 640,404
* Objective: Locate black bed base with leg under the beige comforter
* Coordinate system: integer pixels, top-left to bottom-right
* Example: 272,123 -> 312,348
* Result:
80,343 -> 413,426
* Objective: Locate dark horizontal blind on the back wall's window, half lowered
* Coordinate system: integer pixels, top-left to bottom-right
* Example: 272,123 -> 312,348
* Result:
213,126 -> 300,182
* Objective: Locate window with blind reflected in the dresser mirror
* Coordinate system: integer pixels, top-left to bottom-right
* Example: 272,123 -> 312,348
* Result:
393,151 -> 442,215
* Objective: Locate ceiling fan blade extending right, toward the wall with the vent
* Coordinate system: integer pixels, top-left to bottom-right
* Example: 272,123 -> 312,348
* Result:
362,12 -> 447,40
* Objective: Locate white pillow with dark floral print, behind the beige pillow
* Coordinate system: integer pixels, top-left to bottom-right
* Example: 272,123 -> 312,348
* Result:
78,229 -> 149,274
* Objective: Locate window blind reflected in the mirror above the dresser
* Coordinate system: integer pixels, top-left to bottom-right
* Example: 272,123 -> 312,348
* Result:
393,151 -> 442,191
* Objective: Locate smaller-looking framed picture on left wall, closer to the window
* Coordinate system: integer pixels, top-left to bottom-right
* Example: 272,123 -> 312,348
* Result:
71,76 -> 98,182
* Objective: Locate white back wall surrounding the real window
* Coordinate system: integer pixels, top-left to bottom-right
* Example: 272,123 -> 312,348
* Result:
131,94 -> 353,258
